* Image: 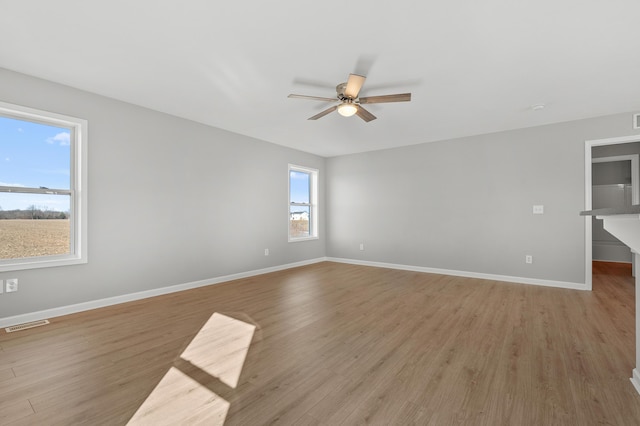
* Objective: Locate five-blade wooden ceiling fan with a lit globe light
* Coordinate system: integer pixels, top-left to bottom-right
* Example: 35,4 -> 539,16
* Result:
288,74 -> 411,123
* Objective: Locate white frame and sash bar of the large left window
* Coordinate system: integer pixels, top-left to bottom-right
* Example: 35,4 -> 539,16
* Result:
0,101 -> 88,272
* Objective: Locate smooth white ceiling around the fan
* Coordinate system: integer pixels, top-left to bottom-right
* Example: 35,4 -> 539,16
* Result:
0,0 -> 640,157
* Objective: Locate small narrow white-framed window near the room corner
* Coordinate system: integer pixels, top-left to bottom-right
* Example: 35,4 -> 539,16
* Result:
289,164 -> 318,241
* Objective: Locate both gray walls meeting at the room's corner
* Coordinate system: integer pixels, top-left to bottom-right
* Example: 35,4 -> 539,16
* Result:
0,65 -> 638,318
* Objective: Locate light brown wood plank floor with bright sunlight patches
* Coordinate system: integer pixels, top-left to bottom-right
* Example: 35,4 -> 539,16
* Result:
0,262 -> 640,425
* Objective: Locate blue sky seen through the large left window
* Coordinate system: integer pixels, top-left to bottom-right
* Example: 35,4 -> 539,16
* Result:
0,116 -> 71,211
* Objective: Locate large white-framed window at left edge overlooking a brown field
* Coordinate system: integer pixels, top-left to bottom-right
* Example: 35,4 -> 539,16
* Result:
0,102 -> 87,271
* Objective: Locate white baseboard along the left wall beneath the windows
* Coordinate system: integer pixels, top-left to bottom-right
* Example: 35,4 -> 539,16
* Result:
0,257 -> 327,328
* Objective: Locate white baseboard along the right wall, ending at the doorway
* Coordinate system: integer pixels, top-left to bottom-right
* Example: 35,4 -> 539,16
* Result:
326,257 -> 589,290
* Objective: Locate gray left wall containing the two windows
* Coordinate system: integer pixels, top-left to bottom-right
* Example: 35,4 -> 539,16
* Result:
0,69 -> 325,318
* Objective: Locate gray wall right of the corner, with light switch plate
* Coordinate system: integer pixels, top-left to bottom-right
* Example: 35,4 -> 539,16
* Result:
327,114 -> 638,283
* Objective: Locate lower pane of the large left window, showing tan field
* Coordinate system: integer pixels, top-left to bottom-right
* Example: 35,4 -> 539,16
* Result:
0,193 -> 71,260
